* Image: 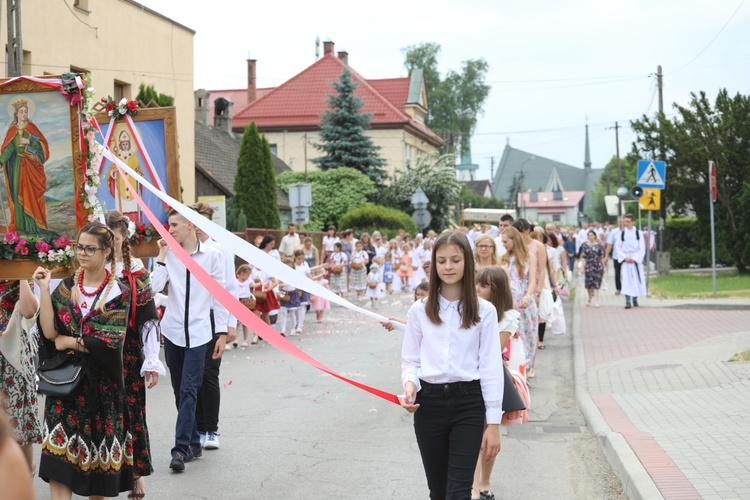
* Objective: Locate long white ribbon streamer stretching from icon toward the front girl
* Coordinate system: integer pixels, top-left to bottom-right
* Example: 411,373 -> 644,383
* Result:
98,145 -> 406,330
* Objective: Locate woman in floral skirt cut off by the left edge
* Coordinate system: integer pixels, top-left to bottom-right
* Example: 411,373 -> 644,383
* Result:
0,280 -> 42,470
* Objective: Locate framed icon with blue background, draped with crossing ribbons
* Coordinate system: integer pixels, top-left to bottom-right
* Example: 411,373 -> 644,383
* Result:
97,107 -> 180,229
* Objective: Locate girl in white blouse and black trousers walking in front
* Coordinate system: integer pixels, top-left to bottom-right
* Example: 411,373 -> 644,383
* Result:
401,231 -> 503,499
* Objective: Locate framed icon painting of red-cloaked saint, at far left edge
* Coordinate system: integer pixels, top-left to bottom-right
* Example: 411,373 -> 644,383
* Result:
0,77 -> 85,241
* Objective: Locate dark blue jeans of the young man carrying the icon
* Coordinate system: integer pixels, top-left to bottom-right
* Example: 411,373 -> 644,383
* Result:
164,337 -> 206,457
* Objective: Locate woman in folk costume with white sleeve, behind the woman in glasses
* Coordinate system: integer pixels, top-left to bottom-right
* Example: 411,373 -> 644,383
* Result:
107,210 -> 167,498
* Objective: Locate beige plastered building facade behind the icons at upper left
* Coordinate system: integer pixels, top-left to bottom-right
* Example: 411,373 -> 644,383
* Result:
0,0 -> 195,203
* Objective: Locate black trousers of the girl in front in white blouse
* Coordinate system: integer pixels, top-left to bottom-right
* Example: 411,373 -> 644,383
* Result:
414,380 -> 485,500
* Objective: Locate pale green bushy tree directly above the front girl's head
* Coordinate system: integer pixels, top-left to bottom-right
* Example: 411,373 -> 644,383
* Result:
378,155 -> 462,231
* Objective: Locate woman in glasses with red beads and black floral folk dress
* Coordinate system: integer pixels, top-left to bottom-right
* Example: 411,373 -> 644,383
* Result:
34,222 -> 134,500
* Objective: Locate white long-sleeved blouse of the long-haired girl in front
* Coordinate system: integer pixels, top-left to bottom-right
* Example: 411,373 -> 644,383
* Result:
401,296 -> 503,424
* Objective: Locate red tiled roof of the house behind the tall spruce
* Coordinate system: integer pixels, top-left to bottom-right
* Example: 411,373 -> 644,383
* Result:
232,53 -> 442,146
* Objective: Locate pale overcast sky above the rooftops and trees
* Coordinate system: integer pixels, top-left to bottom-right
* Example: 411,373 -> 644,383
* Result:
140,0 -> 750,184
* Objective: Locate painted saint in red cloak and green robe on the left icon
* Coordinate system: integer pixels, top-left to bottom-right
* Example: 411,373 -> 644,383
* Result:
0,99 -> 49,235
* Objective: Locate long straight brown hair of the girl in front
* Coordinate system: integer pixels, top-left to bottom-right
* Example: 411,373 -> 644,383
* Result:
425,231 -> 480,329
